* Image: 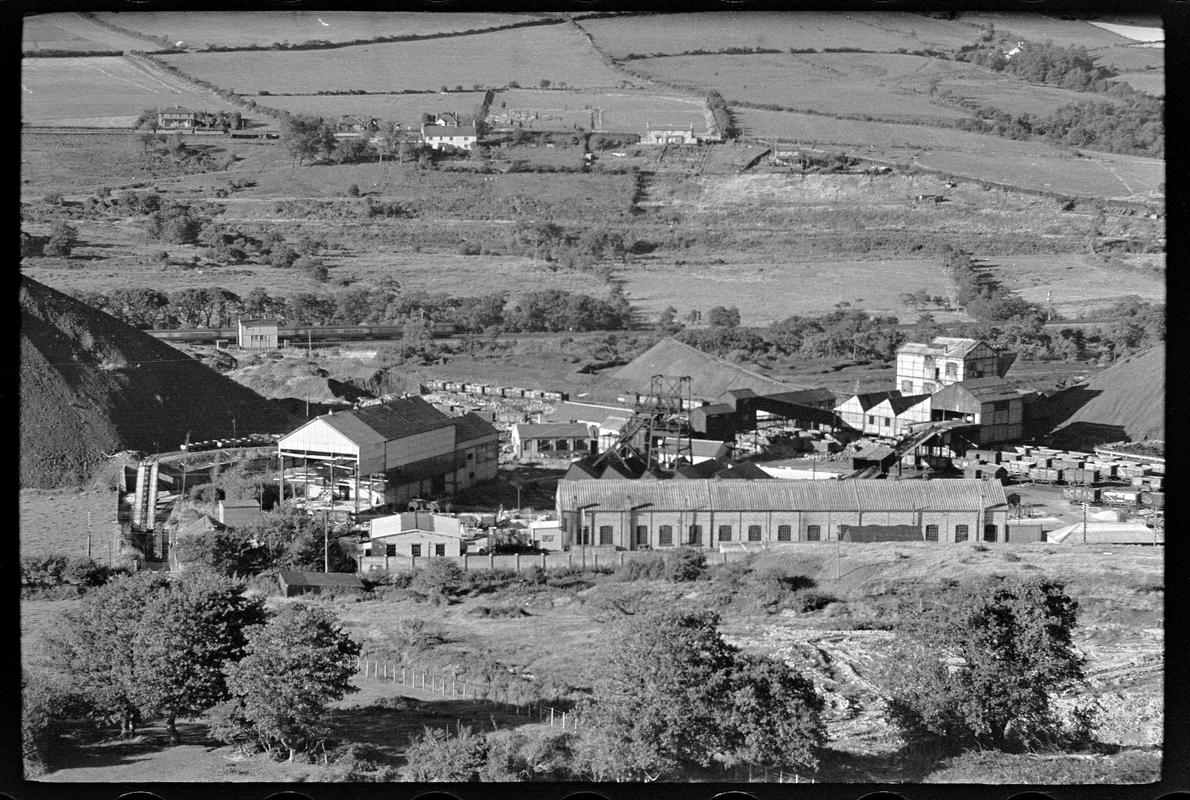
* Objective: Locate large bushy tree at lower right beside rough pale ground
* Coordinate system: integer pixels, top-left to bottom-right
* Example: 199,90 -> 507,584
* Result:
888,577 -> 1092,751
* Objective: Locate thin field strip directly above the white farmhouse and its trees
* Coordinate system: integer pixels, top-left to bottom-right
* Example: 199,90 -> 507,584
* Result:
249,87 -> 483,130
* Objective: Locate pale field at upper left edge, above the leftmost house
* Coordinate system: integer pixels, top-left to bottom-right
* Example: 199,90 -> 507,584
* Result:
20,56 -> 240,127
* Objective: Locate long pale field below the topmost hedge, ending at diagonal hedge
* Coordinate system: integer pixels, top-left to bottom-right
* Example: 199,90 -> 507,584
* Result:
163,25 -> 625,94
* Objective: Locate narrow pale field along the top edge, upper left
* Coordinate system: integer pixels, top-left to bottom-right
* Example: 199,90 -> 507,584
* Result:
95,11 -> 552,48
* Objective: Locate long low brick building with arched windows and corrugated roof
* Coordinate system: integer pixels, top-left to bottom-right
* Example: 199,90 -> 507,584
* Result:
557,480 -> 1008,550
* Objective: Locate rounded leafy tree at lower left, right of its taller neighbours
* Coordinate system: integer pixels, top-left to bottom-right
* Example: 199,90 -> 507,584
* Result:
211,604 -> 359,761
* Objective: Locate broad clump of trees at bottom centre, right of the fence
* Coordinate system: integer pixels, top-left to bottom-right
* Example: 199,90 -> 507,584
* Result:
572,610 -> 826,781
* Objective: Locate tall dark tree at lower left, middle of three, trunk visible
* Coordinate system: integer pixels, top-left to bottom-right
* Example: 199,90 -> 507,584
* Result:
132,571 -> 264,744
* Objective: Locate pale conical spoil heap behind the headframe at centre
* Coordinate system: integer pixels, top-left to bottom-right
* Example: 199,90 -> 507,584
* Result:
605,339 -> 803,400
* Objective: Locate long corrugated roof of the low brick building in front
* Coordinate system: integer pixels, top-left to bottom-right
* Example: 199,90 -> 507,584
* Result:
557,479 -> 1008,511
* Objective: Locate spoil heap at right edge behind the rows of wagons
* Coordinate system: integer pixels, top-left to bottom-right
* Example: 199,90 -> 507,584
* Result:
1050,344 -> 1165,448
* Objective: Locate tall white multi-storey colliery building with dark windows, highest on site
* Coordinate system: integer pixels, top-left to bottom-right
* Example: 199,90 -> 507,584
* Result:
896,336 -> 1016,394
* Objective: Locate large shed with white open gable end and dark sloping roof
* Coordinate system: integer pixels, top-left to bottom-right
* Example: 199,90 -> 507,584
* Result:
277,398 -> 500,512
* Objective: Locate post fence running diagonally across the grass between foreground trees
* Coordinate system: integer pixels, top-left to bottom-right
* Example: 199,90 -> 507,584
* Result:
356,656 -> 580,731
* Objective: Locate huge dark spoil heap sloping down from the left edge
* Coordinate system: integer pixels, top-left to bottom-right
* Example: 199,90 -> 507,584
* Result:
20,279 -> 299,487
